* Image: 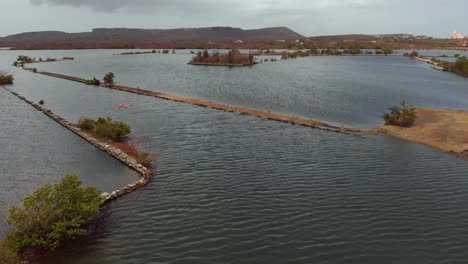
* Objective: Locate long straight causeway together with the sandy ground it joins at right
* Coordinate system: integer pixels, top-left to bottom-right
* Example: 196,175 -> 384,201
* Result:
16,62 -> 468,159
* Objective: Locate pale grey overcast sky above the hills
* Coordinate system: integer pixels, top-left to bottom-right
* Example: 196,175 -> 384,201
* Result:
0,0 -> 468,37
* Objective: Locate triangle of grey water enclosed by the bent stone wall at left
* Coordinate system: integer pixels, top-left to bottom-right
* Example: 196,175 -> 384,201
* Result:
0,88 -> 138,237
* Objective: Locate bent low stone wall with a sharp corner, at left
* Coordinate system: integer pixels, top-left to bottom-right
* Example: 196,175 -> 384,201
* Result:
4,87 -> 152,202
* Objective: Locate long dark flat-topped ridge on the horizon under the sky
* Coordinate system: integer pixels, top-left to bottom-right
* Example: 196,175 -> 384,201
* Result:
0,27 -> 304,47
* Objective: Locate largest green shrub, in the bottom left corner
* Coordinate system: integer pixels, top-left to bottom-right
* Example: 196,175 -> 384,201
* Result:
5,175 -> 104,253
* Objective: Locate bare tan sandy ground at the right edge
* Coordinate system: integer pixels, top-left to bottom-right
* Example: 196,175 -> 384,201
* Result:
377,108 -> 468,158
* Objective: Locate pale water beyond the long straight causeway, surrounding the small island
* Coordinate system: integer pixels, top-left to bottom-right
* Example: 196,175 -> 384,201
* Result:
20,51 -> 468,128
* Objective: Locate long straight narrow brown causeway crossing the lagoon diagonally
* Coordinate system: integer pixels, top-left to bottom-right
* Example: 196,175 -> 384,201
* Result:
29,68 -> 374,133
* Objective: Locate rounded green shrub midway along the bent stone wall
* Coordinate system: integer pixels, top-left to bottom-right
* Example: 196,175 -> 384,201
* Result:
94,117 -> 131,142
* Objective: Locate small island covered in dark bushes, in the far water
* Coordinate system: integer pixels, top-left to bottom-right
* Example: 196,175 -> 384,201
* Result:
188,49 -> 257,67
